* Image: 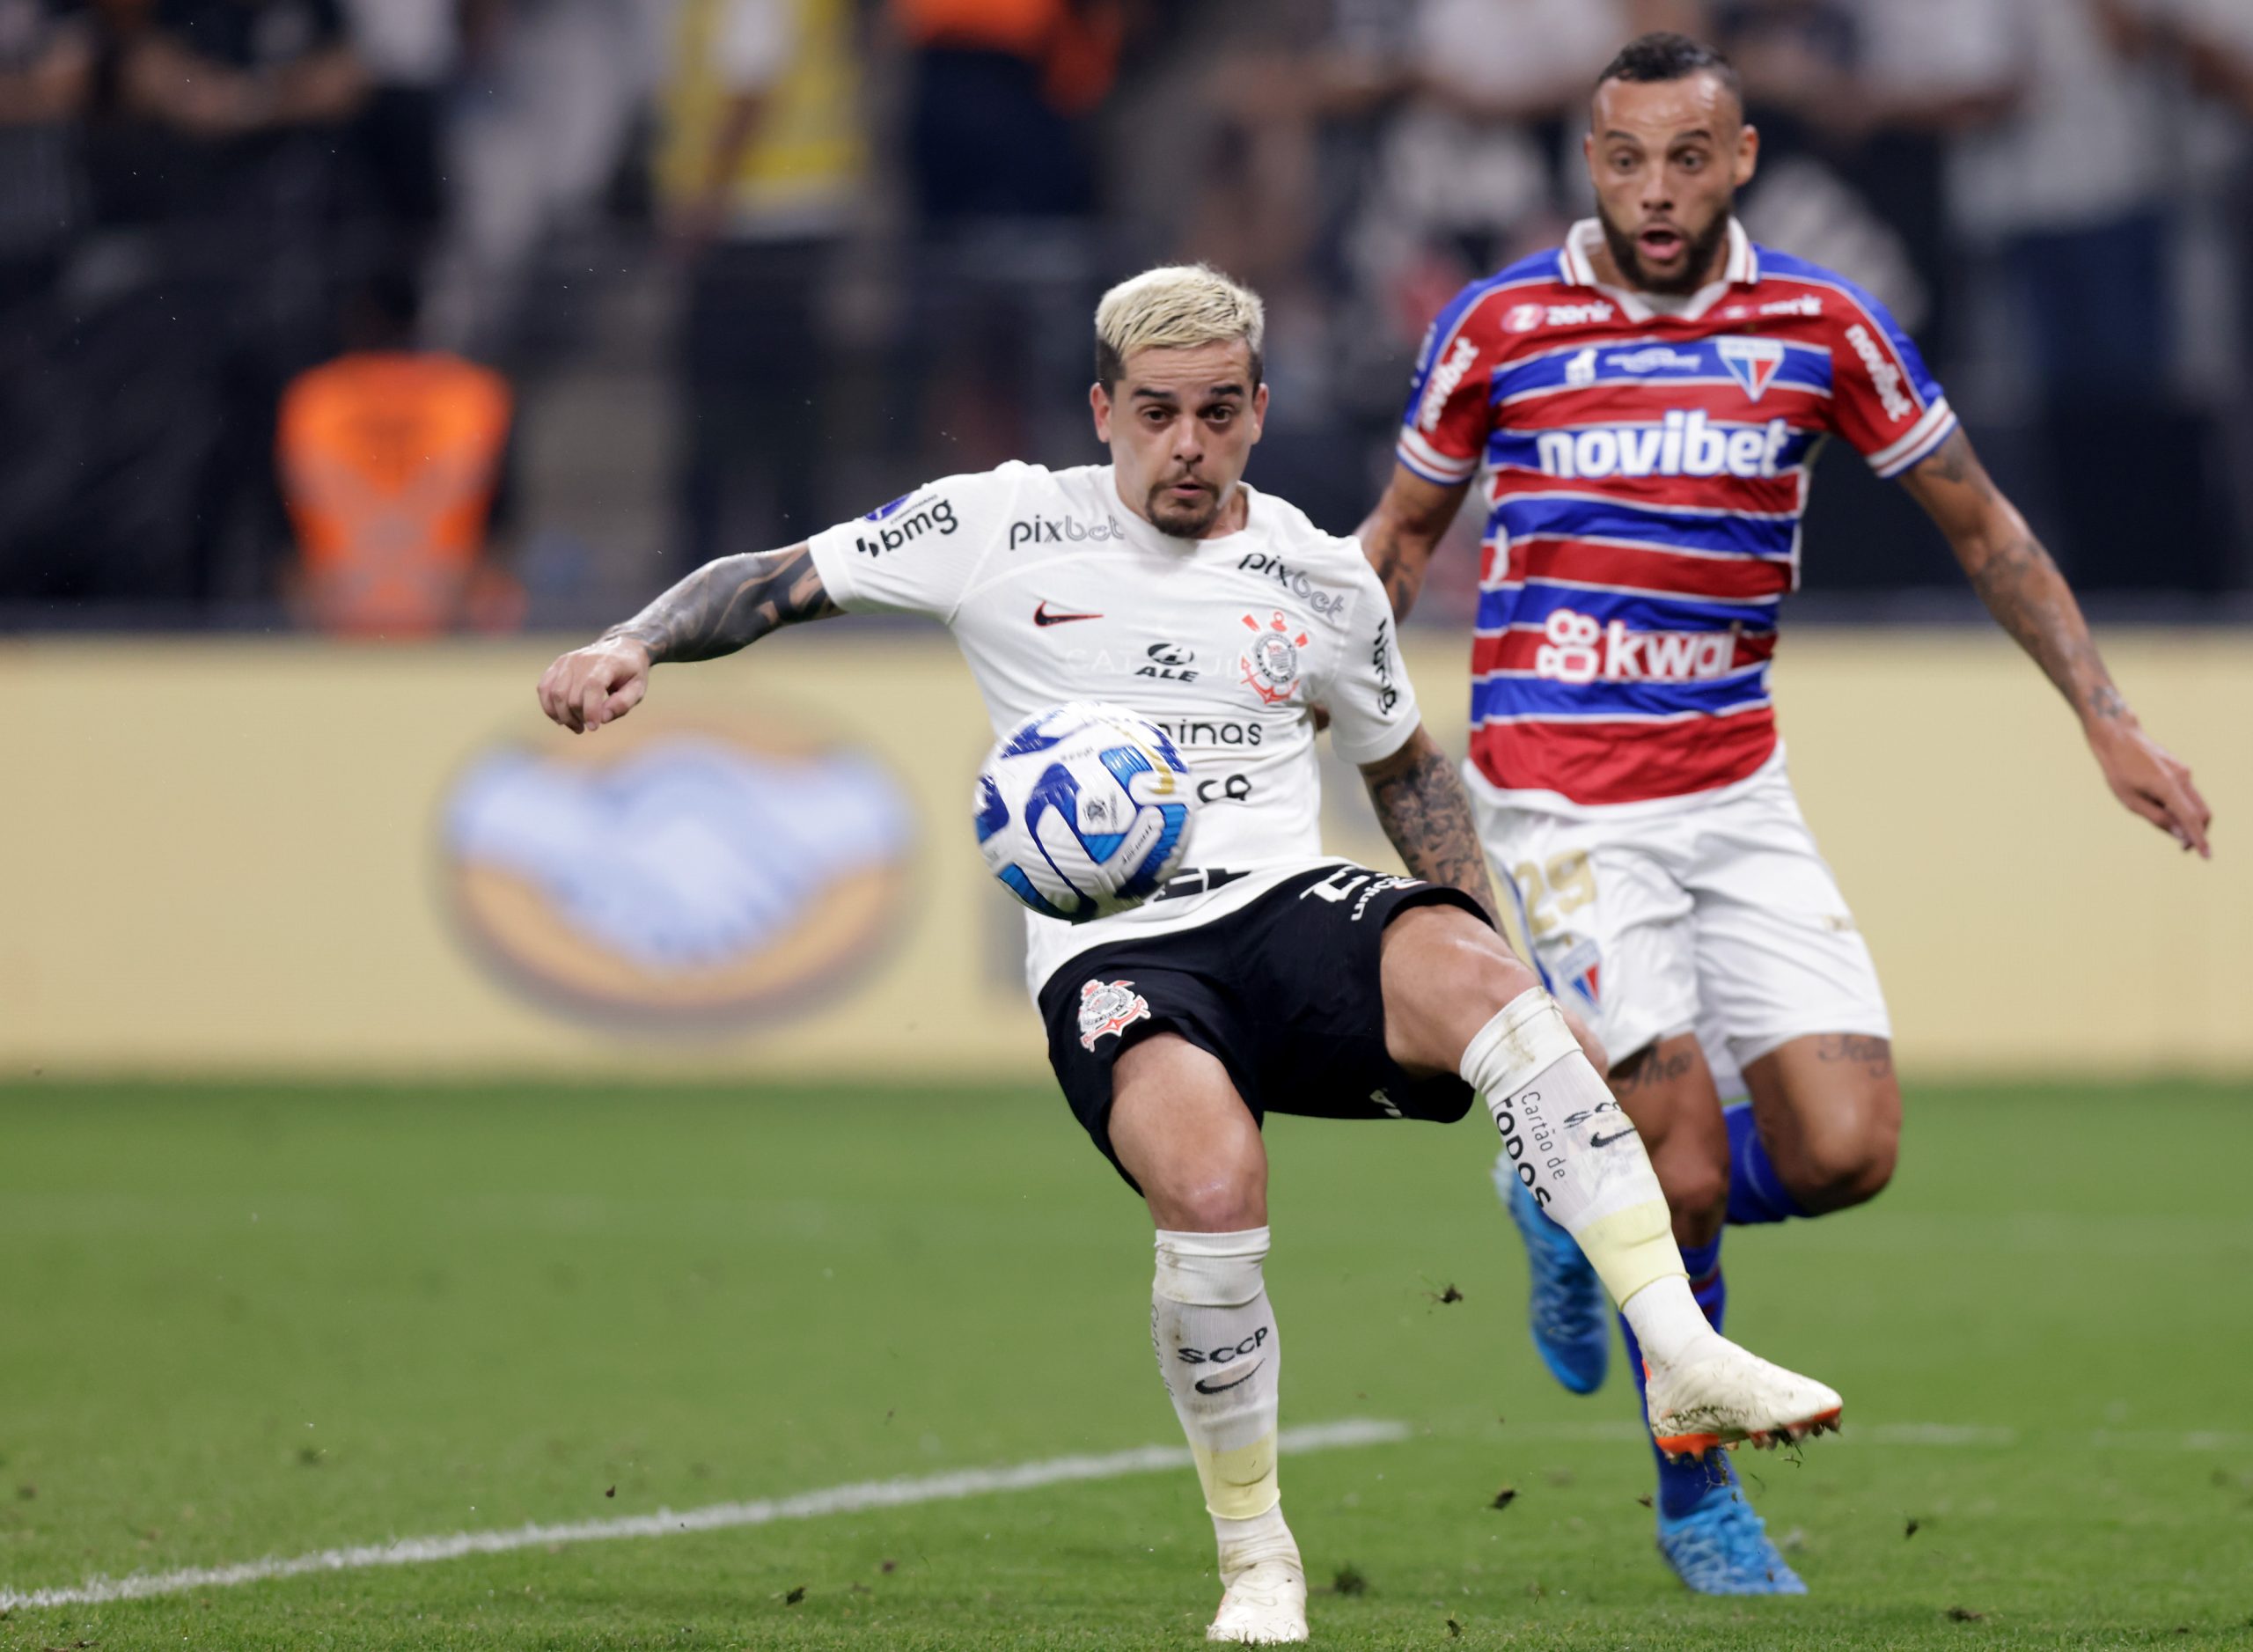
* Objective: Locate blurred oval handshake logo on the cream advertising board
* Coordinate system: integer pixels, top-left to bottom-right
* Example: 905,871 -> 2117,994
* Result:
437,706 -> 914,1032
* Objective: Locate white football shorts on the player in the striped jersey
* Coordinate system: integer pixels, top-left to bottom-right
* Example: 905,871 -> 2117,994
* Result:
1464,753 -> 1892,1068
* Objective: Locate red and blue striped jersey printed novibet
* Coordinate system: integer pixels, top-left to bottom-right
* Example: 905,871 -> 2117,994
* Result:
1399,218 -> 1956,807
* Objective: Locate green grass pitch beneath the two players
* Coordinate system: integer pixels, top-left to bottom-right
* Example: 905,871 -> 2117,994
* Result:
0,1068 -> 2253,1652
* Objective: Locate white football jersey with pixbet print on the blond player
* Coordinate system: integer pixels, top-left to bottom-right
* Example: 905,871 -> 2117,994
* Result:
811,462 -> 1420,994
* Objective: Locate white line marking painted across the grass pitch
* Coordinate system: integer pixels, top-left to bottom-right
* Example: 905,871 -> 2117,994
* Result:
0,1418 -> 1408,1612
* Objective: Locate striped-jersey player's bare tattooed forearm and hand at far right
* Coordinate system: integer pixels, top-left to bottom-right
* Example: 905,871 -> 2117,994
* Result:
1902,430 -> 2214,855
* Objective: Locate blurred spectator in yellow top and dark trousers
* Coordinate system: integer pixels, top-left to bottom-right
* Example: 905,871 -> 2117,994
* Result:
658,0 -> 868,562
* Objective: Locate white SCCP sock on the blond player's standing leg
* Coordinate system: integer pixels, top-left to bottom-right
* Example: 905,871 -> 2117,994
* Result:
1149,1229 -> 1298,1589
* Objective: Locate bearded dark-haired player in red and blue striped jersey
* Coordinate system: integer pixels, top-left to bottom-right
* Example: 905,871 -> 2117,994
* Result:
1361,33 -> 2210,1593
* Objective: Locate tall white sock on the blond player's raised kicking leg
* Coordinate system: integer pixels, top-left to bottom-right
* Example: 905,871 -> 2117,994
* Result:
1462,988 -> 1714,1366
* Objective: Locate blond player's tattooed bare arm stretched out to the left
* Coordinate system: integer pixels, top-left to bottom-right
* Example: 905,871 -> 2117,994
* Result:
539,546 -> 840,735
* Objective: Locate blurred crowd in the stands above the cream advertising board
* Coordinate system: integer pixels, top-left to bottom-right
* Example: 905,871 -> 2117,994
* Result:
0,0 -> 2253,635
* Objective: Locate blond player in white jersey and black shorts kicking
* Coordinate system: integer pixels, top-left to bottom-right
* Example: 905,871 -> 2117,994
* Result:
539,268 -> 1838,1641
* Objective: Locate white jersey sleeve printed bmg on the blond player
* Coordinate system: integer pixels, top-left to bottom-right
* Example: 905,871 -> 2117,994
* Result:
806,462 -> 1025,620
